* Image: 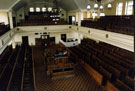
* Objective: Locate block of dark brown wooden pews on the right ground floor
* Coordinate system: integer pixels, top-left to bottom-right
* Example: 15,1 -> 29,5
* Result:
70,39 -> 135,91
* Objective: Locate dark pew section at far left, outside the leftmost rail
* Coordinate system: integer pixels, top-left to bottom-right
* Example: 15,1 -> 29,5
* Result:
0,46 -> 20,91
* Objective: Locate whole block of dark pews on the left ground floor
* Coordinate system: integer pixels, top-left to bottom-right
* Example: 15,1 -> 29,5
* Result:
0,45 -> 34,91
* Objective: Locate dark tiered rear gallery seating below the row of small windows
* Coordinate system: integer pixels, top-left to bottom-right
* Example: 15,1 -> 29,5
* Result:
18,12 -> 67,26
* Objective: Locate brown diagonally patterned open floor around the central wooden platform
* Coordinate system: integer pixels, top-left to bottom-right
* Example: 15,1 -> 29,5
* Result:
33,47 -> 102,91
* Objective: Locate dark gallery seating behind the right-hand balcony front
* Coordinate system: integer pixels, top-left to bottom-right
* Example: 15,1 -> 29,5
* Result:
81,16 -> 135,35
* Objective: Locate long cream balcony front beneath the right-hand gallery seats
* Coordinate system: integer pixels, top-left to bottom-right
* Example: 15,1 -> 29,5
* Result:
73,26 -> 134,52
